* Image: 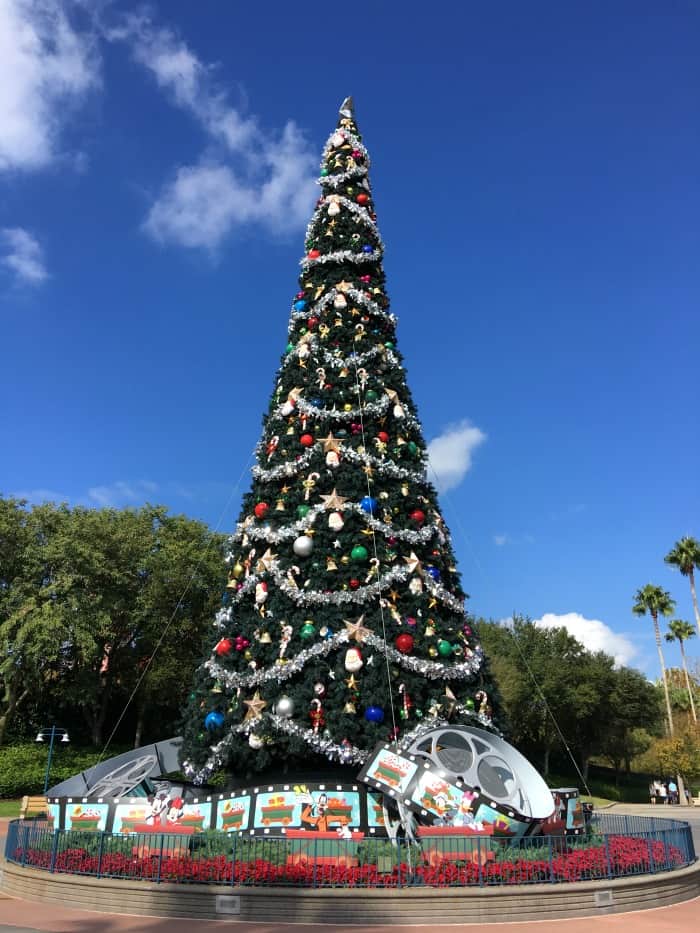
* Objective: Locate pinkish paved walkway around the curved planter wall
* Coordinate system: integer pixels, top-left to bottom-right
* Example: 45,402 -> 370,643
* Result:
0,804 -> 700,933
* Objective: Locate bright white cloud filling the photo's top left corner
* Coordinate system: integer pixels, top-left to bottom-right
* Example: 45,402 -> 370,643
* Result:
0,0 -> 99,171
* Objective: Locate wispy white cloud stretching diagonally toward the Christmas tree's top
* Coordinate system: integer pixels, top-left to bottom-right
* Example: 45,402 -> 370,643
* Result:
107,15 -> 316,250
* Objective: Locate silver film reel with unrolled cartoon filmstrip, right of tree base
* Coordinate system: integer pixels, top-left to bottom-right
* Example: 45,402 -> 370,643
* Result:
358,726 -> 554,836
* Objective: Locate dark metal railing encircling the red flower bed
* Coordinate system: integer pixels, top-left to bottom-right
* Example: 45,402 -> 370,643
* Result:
5,813 -> 695,888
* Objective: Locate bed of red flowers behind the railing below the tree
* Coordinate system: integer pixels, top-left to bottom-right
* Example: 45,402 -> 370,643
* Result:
8,835 -> 687,888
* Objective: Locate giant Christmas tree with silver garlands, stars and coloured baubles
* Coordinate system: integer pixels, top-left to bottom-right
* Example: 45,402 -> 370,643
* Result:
183,99 -> 498,782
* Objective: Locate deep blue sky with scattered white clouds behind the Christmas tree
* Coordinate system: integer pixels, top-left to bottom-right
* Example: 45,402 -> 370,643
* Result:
0,0 -> 700,675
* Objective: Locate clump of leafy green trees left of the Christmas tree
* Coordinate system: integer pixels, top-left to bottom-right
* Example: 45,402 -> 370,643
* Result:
0,500 -> 225,745
